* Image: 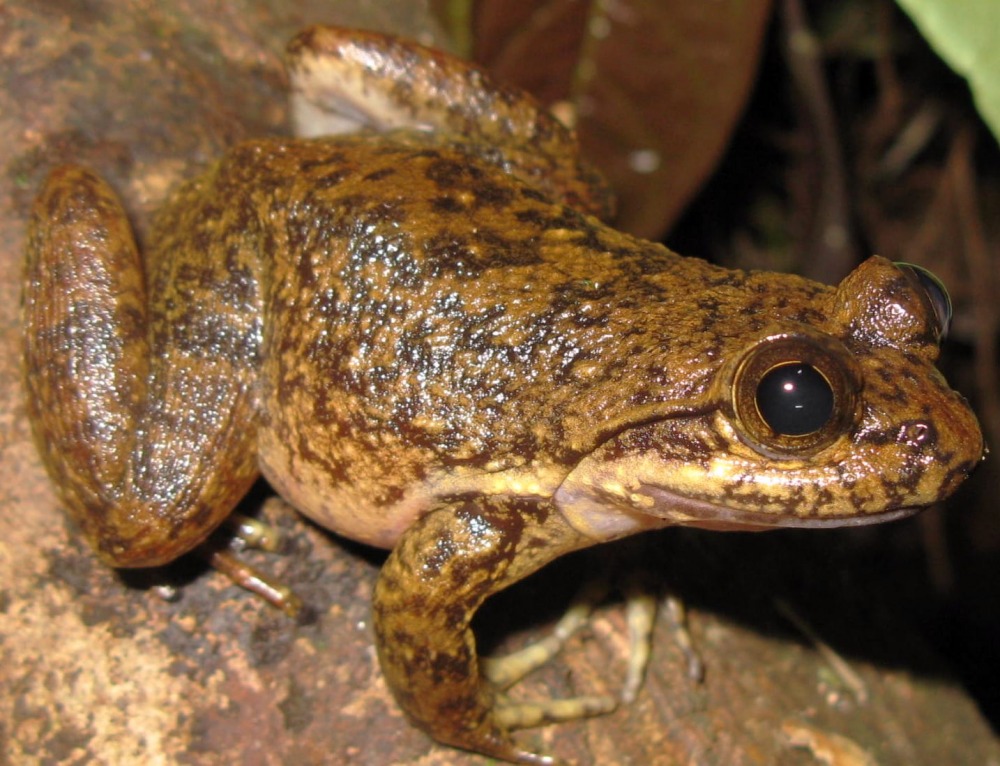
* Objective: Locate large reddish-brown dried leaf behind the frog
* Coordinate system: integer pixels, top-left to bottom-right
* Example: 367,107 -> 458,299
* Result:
472,0 -> 771,237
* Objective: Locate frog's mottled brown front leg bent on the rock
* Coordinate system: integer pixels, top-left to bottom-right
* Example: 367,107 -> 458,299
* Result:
374,497 -> 607,763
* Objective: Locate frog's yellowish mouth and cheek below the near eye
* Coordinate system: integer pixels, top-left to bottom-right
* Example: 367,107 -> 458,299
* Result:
553,402 -> 947,540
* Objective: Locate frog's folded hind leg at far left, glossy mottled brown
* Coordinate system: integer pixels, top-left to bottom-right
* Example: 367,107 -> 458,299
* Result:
23,166 -> 257,567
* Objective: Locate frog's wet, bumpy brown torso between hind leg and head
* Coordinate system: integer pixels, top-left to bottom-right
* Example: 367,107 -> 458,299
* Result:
203,134 -> 812,546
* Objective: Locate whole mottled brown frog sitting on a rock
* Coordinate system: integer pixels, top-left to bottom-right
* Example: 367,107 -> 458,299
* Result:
22,26 -> 985,764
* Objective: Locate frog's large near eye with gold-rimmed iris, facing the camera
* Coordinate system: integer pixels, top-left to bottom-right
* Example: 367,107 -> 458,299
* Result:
732,335 -> 858,457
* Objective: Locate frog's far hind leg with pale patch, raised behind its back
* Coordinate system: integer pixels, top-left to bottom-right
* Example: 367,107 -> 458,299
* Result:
286,26 -> 614,220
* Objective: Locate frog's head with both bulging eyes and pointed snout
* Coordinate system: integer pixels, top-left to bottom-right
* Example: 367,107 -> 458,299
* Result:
555,258 -> 984,539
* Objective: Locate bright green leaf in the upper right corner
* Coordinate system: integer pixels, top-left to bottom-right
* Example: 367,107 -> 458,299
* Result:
897,0 -> 1000,146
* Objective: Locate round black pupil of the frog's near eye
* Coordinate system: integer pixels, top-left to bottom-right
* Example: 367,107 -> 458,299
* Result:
757,362 -> 833,436
